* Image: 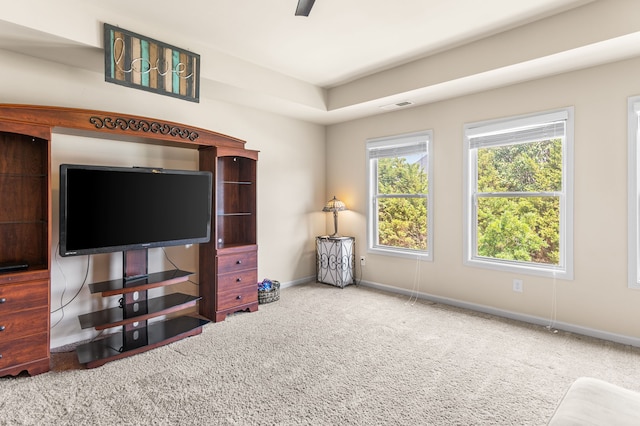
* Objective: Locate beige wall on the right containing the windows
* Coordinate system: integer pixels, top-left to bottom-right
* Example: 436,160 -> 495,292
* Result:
327,59 -> 640,344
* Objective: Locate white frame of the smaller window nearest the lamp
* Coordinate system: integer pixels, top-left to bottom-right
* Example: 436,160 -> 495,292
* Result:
366,130 -> 433,261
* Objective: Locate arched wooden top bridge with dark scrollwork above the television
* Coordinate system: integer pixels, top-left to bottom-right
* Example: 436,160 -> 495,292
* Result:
0,104 -> 245,148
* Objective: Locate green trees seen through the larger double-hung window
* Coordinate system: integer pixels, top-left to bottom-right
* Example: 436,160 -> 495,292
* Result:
476,139 -> 562,265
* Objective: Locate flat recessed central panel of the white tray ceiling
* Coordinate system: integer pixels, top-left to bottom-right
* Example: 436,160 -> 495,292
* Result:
94,0 -> 585,87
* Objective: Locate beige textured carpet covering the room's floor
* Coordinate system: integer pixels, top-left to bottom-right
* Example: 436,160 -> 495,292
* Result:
0,283 -> 640,425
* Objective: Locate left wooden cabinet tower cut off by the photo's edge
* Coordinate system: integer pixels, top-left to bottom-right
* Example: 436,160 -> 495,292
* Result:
0,123 -> 51,376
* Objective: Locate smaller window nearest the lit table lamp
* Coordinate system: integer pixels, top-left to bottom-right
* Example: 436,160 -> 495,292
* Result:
367,131 -> 433,260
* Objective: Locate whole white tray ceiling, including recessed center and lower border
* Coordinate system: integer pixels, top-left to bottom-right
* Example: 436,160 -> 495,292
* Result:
0,0 -> 640,124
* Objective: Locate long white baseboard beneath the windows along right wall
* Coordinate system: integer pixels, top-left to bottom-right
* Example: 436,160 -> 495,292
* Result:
359,281 -> 640,347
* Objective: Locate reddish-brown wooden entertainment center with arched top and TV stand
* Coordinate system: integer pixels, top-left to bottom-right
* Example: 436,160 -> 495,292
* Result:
0,104 -> 258,376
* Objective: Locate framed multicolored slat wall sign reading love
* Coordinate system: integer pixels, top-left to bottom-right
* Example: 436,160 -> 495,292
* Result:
104,24 -> 200,102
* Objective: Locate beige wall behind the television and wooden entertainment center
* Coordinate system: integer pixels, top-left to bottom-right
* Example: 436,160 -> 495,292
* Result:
0,50 -> 326,347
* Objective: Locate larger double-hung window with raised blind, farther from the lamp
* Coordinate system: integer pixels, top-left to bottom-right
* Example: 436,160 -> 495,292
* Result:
464,109 -> 573,279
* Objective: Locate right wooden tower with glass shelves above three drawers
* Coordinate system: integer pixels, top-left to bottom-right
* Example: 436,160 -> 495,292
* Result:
200,148 -> 258,322
